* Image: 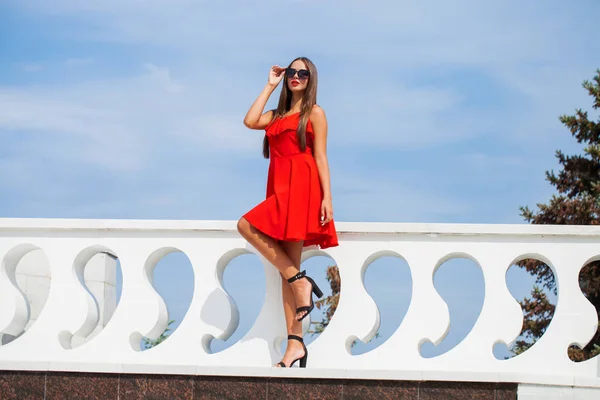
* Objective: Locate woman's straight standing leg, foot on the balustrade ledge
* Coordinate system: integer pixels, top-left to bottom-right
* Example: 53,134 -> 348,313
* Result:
280,242 -> 304,365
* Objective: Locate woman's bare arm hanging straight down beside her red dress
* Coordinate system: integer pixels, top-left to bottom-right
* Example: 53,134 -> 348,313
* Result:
310,106 -> 333,225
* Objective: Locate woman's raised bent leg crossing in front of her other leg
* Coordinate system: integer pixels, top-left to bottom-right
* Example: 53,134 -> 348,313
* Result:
237,217 -> 312,319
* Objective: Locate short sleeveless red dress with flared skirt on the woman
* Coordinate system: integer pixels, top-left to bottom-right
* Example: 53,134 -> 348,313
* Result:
244,113 -> 338,249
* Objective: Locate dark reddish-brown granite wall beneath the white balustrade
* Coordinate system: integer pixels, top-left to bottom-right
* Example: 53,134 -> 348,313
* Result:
0,371 -> 517,400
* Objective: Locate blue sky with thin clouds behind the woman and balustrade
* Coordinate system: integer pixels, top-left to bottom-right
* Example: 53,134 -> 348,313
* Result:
0,0 -> 600,360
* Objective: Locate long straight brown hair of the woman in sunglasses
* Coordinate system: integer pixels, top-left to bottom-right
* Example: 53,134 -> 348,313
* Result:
263,57 -> 318,158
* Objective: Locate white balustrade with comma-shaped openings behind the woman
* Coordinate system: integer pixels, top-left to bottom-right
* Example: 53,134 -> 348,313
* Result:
0,219 -> 600,387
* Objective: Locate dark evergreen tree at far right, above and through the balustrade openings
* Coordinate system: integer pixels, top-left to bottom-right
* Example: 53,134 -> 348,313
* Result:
515,69 -> 600,361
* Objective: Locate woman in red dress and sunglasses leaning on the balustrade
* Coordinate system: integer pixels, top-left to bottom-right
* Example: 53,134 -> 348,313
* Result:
238,57 -> 338,367
